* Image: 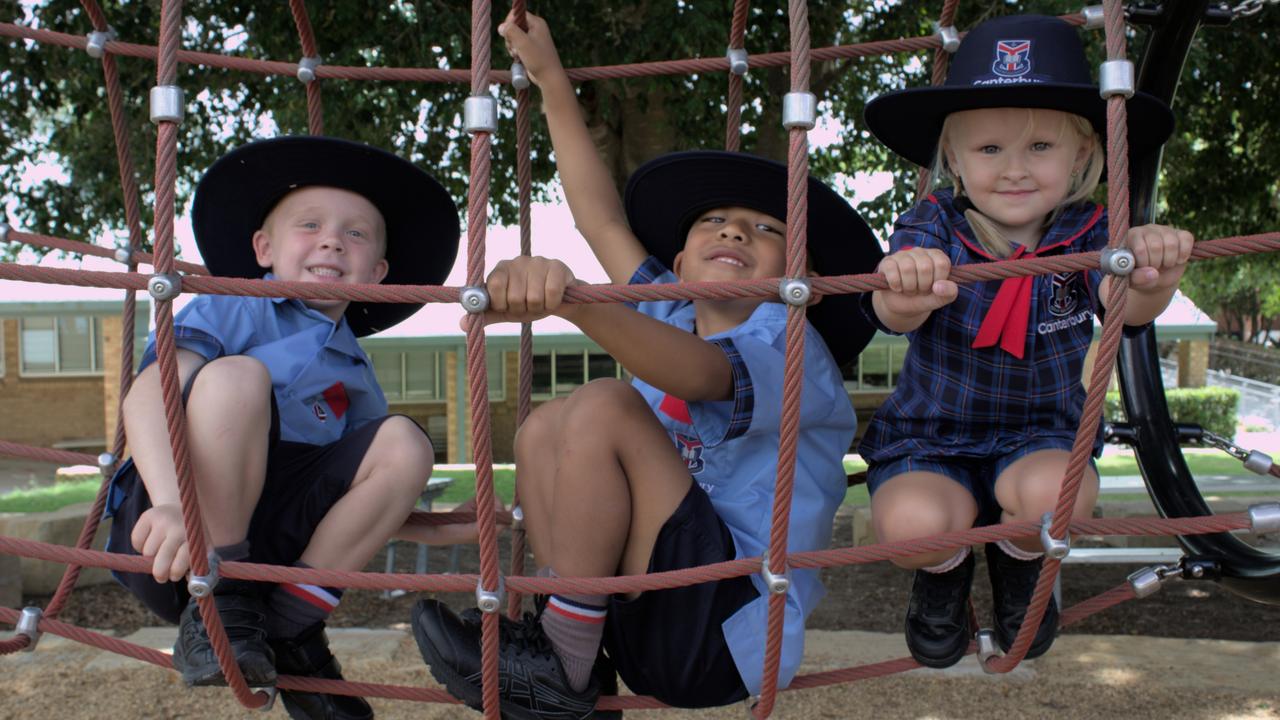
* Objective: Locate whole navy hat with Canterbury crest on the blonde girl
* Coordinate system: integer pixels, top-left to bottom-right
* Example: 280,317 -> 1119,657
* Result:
865,15 -> 1174,174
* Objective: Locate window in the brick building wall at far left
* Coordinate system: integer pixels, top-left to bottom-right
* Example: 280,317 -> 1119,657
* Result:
18,316 -> 102,375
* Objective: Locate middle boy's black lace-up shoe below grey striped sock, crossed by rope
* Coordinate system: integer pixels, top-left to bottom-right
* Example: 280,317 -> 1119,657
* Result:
412,600 -> 600,720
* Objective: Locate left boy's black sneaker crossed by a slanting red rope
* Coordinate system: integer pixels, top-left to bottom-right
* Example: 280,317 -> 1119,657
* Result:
173,578 -> 275,687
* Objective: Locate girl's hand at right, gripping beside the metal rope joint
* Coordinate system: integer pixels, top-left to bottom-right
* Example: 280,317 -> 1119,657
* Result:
1098,224 -> 1196,325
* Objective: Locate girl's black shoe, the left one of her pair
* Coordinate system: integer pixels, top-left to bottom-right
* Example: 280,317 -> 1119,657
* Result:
906,552 -> 974,667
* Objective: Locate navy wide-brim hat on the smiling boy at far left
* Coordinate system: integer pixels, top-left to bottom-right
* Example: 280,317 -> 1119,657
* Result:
191,136 -> 460,336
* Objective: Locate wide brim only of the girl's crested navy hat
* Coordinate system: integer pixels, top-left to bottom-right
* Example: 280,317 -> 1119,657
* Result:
864,83 -> 1174,177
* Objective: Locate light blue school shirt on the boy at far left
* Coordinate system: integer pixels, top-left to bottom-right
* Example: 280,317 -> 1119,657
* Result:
140,274 -> 387,445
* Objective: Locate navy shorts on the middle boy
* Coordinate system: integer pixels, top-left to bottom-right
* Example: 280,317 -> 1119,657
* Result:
604,483 -> 760,707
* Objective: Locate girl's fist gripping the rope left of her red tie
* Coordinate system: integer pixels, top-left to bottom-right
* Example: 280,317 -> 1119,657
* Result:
872,247 -> 960,333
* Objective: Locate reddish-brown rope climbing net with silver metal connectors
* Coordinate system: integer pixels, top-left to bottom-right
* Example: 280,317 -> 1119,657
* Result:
0,0 -> 1280,719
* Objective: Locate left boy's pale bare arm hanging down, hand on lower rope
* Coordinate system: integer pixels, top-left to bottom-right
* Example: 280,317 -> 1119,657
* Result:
123,348 -> 205,583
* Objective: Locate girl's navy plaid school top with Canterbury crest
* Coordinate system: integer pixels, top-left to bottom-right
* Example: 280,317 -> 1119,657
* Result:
859,188 -> 1107,462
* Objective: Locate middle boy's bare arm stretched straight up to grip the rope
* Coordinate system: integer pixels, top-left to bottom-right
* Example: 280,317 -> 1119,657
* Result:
498,14 -> 648,284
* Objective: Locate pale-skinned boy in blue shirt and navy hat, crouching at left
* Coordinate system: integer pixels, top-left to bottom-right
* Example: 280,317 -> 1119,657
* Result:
109,137 -> 458,719
